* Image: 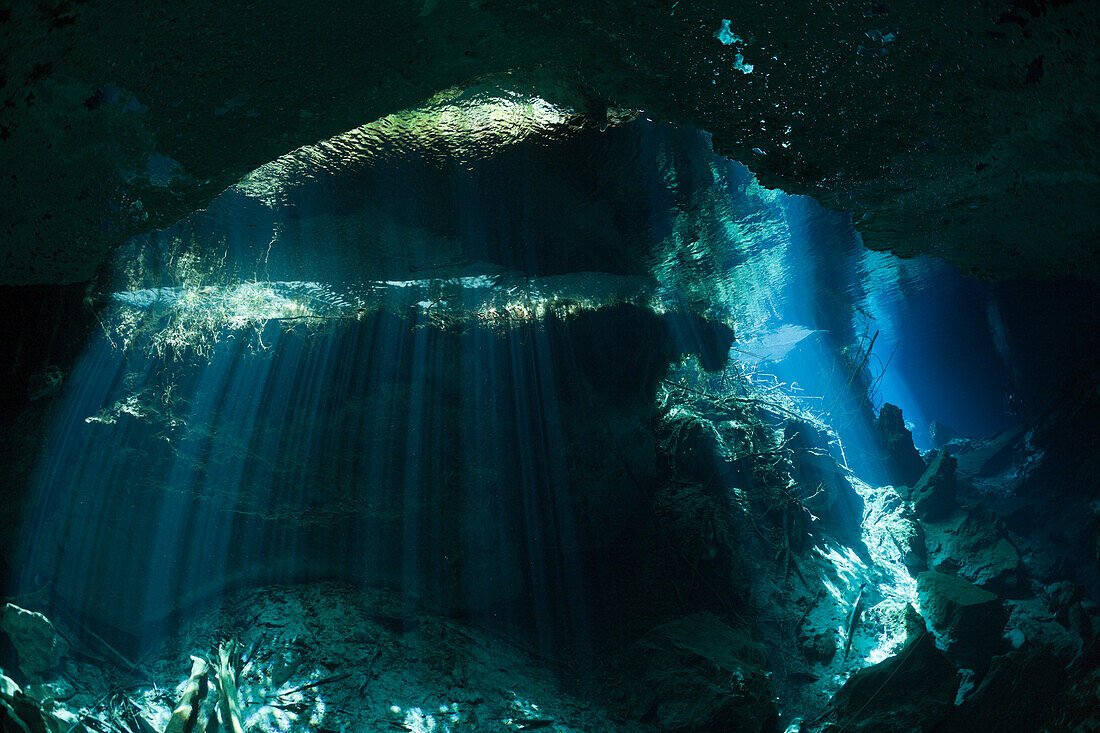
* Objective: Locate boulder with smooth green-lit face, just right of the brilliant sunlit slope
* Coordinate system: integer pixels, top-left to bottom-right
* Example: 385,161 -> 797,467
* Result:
916,570 -> 1005,670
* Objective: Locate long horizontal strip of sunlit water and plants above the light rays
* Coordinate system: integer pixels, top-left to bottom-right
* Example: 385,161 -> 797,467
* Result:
101,273 -> 666,355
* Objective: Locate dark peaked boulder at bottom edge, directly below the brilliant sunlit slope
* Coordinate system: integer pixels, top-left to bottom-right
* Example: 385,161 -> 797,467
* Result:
829,634 -> 958,733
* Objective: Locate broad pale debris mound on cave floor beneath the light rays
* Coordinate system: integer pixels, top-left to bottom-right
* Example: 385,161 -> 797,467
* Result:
6,582 -> 657,733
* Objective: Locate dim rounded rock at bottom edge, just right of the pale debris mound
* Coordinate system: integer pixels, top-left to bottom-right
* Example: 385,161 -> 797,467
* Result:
630,613 -> 779,732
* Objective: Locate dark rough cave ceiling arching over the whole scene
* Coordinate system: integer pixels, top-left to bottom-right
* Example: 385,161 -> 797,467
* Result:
0,0 -> 1100,284
